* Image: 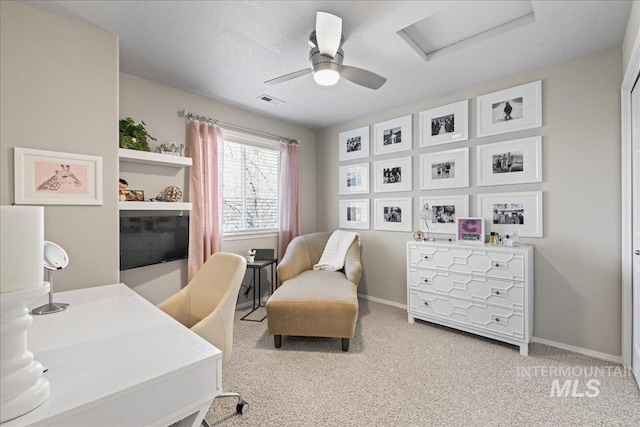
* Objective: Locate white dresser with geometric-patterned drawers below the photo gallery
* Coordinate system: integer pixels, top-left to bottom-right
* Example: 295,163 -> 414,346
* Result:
407,242 -> 533,356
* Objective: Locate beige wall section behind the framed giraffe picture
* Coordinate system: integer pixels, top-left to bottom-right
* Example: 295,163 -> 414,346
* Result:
0,1 -> 119,291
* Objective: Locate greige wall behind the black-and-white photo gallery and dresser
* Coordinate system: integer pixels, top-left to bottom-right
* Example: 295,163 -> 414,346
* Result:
317,47 -> 622,356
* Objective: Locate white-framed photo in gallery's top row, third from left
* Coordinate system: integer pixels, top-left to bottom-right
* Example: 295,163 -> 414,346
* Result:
420,100 -> 469,147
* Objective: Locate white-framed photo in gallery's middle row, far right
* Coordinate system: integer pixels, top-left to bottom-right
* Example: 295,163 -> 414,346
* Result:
476,136 -> 542,185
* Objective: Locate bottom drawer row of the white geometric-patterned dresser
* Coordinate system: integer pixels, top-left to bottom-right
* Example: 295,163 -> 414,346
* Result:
408,289 -> 524,339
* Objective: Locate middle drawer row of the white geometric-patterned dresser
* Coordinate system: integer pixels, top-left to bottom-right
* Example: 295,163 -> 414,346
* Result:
408,267 -> 524,311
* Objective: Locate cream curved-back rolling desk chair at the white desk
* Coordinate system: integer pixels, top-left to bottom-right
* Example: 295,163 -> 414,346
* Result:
158,252 -> 248,425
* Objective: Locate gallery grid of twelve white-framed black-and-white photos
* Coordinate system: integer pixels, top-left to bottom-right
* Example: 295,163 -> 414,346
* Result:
338,80 -> 544,240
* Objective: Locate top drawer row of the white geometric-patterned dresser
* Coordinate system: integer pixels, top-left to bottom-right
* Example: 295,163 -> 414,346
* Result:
408,245 -> 524,281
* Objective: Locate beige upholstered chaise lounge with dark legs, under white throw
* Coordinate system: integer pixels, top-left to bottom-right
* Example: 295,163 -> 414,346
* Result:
267,232 -> 362,351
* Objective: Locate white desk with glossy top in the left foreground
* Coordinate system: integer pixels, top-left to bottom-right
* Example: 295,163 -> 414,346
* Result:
1,284 -> 222,427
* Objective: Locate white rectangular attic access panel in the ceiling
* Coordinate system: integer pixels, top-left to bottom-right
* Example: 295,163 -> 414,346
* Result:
397,0 -> 535,61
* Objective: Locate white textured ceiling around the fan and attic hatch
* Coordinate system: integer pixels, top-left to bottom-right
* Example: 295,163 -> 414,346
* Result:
23,0 -> 631,129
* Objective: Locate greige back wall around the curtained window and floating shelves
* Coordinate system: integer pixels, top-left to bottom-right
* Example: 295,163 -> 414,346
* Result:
120,73 -> 316,303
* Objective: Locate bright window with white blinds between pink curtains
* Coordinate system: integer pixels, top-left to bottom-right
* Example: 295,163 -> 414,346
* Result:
223,135 -> 280,235
